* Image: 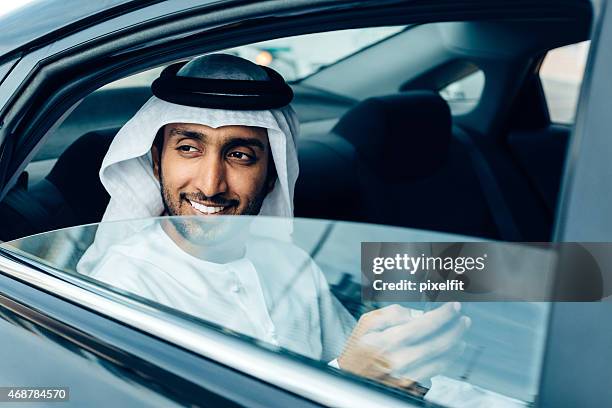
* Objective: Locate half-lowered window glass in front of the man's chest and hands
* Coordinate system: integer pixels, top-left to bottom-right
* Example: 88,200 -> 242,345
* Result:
2,216 -> 549,406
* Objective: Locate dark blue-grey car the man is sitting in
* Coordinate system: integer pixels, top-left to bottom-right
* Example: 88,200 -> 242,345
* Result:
0,0 -> 612,407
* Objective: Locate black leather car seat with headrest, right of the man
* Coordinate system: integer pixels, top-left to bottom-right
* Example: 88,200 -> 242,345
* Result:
295,91 -> 498,237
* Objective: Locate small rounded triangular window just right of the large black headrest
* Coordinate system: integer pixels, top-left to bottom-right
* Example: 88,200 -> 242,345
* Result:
440,69 -> 485,115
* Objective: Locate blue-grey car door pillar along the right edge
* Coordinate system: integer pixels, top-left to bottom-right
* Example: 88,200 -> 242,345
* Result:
538,0 -> 612,407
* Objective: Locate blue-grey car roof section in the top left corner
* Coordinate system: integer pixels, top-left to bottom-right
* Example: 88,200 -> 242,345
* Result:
0,0 -> 159,59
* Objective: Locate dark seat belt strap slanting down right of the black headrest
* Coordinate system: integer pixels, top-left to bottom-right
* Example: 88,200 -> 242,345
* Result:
453,126 -> 521,242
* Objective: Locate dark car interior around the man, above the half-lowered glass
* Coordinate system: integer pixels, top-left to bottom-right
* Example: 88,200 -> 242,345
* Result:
0,16 -> 590,241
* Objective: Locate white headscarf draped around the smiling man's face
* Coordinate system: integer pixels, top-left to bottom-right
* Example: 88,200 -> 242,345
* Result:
78,54 -> 299,273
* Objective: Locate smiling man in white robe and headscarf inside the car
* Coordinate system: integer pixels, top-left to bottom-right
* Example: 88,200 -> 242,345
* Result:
78,55 -> 469,396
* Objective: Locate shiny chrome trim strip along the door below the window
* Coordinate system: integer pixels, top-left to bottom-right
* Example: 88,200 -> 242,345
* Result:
0,253 -> 416,408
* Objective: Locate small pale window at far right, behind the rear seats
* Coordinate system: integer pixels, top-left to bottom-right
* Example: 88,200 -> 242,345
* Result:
540,41 -> 591,124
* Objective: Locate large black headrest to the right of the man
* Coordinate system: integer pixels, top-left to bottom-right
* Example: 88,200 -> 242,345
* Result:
332,91 -> 452,181
